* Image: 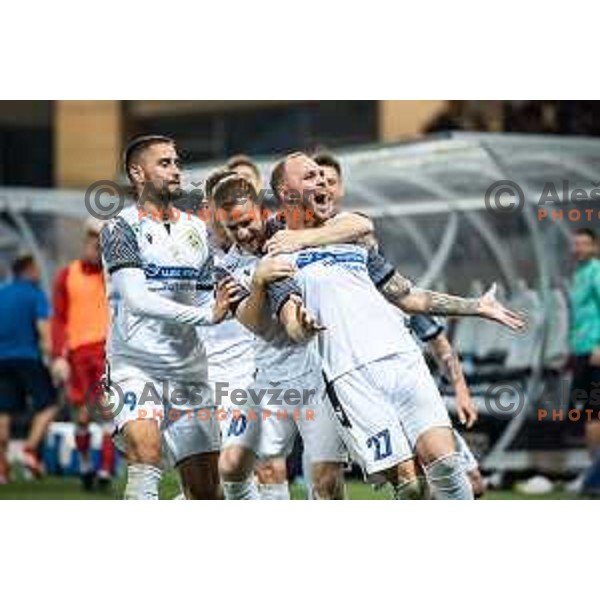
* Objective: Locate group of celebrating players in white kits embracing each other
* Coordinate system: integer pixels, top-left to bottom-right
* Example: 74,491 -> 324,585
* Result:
101,136 -> 525,500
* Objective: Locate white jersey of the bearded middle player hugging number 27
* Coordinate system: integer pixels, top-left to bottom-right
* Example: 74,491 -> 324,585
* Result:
220,246 -> 321,383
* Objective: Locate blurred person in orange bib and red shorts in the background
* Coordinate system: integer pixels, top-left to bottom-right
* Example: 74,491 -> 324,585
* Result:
52,219 -> 114,489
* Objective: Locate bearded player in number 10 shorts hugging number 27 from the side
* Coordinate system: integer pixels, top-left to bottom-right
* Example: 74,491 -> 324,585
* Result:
212,173 -> 356,499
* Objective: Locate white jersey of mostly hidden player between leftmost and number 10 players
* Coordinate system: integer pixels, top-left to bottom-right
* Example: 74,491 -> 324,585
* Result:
199,241 -> 256,384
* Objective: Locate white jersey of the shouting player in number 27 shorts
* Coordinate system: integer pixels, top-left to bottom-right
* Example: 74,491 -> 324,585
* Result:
282,244 -> 419,381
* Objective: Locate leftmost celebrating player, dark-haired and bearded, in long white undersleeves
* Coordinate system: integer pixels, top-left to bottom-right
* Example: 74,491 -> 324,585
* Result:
101,136 -> 239,500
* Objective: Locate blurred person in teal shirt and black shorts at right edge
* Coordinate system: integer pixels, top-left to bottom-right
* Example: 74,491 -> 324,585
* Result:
569,229 -> 600,494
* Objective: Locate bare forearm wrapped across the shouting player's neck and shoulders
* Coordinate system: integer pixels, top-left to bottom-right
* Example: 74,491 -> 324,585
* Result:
265,213 -> 374,254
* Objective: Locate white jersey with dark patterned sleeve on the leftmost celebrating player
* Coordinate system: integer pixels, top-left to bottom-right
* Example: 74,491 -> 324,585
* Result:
101,206 -> 213,382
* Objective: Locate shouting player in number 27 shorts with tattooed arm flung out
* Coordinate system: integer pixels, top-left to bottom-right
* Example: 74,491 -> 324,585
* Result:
264,153 -> 524,499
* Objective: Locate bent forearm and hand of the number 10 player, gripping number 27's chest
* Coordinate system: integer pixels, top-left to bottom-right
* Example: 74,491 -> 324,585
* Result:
235,257 -> 295,335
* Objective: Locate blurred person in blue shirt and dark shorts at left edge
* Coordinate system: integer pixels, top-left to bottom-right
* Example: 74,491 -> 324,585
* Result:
0,255 -> 57,484
